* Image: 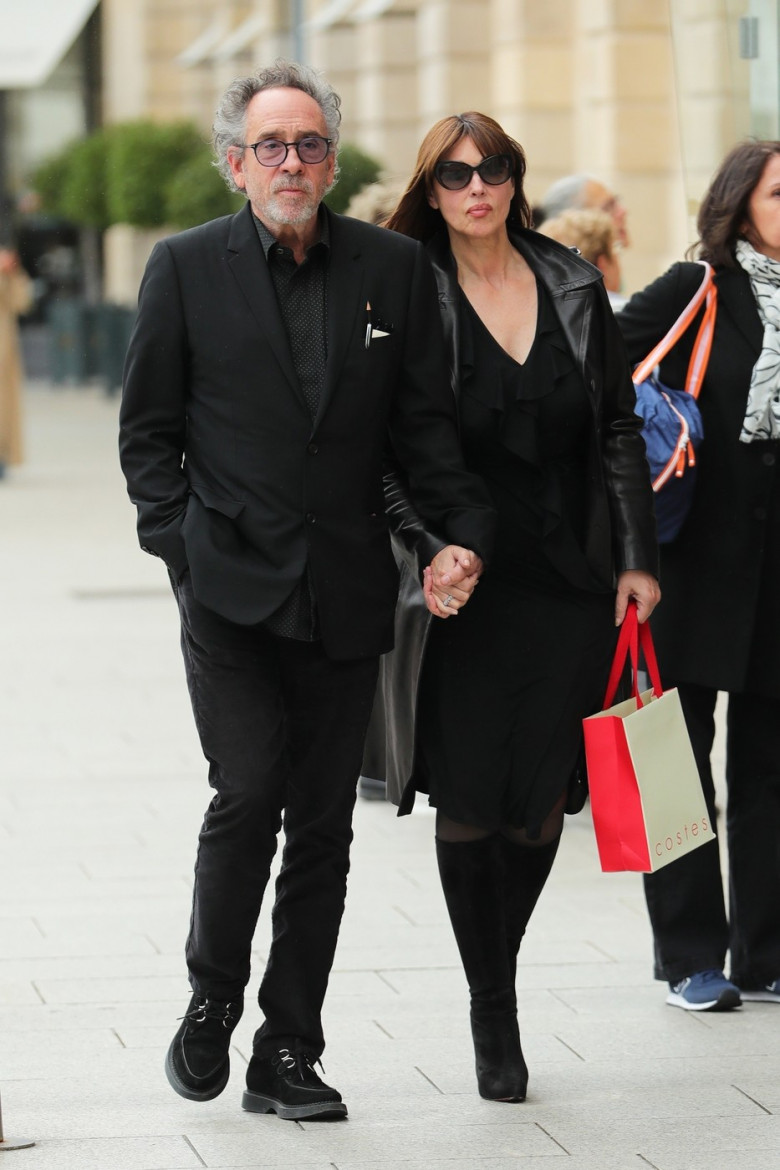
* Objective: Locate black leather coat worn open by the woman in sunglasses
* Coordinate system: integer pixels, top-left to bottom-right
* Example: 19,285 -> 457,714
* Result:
364,221 -> 657,812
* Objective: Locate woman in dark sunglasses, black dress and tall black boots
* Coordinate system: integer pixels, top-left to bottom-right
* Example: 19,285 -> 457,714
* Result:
370,113 -> 660,1101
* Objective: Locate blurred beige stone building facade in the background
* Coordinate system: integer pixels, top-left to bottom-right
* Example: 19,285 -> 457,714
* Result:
6,0 -> 780,300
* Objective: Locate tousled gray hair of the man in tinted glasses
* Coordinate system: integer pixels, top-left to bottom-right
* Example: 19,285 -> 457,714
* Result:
212,59 -> 341,193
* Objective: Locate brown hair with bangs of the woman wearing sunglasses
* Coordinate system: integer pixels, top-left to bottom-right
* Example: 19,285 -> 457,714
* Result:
386,111 -> 531,242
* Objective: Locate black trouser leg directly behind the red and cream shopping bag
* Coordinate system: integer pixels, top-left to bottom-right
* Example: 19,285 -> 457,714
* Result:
644,684 -> 729,983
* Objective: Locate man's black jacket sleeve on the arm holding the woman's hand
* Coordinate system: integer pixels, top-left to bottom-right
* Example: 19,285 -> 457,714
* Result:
386,245 -> 496,563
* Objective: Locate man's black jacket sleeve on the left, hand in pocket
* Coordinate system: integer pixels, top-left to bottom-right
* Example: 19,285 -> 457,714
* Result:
119,241 -> 188,577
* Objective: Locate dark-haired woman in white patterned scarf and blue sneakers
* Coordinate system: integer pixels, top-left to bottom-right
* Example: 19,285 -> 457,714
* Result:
617,142 -> 780,1011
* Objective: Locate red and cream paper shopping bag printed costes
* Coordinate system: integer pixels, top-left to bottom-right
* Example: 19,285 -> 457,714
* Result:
582,603 -> 715,873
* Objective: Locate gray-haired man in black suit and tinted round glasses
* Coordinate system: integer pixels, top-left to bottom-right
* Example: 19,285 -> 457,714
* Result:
120,62 -> 493,1119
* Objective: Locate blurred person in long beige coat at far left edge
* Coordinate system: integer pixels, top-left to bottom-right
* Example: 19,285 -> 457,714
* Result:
0,248 -> 33,476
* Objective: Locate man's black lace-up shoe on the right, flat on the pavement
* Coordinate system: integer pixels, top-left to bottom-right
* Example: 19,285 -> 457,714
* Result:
241,1048 -> 346,1121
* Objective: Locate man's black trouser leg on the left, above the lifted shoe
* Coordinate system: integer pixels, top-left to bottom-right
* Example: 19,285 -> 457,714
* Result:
177,576 -> 287,1002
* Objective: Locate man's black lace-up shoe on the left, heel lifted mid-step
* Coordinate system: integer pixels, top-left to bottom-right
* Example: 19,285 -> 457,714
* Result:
165,995 -> 243,1101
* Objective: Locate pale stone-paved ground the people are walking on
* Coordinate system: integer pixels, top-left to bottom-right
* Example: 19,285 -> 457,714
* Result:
0,384 -> 780,1170
